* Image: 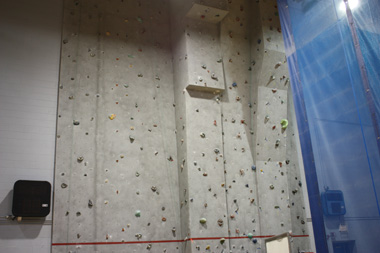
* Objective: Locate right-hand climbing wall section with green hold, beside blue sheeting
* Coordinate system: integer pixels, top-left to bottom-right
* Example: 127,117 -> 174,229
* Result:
251,0 -> 312,252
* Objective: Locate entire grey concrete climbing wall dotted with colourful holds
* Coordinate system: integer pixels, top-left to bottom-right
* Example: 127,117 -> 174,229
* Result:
52,0 -> 309,252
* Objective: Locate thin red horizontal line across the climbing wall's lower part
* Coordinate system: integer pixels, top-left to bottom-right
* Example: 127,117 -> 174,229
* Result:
51,235 -> 309,246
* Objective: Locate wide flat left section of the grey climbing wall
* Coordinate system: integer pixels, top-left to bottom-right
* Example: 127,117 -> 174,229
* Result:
53,0 -> 180,252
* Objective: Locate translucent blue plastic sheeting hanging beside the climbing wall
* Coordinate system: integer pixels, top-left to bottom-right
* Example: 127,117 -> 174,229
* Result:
278,0 -> 380,253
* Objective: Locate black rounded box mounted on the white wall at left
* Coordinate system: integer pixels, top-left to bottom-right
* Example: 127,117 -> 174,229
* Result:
12,180 -> 51,217
